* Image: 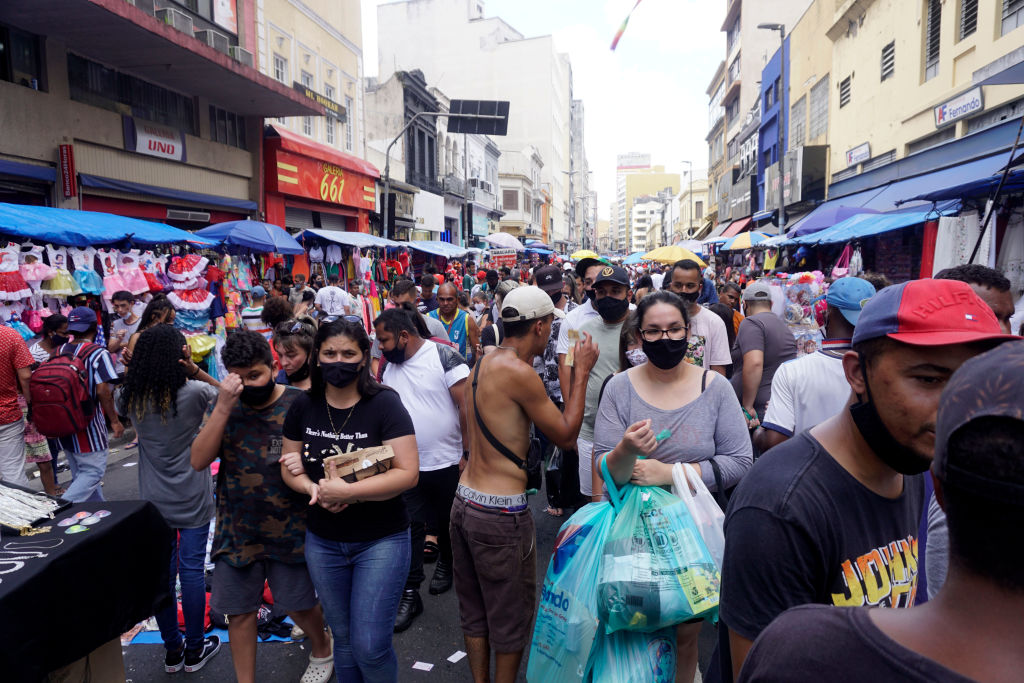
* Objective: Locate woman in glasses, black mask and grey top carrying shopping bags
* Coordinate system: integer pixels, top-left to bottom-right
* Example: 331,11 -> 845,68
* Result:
594,291 -> 753,681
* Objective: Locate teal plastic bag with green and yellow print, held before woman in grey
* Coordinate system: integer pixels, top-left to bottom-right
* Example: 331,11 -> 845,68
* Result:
597,462 -> 722,633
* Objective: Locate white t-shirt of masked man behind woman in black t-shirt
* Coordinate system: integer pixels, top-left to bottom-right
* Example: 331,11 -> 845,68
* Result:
382,340 -> 469,472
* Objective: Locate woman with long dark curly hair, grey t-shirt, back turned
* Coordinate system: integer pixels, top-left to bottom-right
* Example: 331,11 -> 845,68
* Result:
117,325 -> 219,673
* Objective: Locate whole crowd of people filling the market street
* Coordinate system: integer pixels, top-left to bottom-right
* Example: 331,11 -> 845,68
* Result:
0,246 -> 1024,682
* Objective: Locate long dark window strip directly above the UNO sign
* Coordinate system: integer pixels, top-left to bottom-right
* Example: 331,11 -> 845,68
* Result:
68,52 -> 199,135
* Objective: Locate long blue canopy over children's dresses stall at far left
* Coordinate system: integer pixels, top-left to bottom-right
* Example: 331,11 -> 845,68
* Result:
0,204 -> 214,247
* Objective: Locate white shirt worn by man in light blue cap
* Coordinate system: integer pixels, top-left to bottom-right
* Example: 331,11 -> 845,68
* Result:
763,351 -> 850,436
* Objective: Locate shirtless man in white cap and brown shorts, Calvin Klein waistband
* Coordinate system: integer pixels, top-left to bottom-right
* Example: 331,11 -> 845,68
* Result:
452,287 -> 598,683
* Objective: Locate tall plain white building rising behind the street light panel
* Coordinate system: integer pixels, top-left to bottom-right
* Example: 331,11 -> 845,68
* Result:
377,0 -> 573,242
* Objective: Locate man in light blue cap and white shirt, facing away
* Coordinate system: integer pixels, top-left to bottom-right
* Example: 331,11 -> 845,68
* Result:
754,278 -> 874,453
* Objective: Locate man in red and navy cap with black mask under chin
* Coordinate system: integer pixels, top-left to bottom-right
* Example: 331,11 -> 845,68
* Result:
720,280 -> 1008,680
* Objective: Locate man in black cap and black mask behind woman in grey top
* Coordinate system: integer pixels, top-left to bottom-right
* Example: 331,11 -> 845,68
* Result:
577,265 -> 630,497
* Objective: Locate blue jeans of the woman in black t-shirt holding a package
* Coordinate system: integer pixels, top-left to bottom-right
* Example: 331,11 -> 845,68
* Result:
306,528 -> 412,683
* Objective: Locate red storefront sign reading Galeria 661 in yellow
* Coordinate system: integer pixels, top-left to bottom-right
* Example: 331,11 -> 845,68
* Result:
267,150 -> 376,213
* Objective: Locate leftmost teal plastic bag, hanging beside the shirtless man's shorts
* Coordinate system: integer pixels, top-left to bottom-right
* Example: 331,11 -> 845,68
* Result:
526,503 -> 615,682
